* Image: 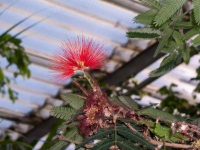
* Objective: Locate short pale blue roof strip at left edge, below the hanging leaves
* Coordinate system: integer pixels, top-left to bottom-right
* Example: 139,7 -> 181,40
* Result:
0,98 -> 33,115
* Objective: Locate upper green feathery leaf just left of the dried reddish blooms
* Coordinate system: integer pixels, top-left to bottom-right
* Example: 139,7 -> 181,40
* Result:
61,93 -> 84,110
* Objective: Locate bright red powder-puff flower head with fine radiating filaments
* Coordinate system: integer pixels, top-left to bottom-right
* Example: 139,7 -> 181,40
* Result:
50,36 -> 108,81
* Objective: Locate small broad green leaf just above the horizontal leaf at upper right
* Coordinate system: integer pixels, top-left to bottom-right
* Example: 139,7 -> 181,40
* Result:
134,9 -> 158,25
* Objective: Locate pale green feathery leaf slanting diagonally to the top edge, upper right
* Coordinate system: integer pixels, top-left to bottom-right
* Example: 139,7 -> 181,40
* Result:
154,0 -> 187,26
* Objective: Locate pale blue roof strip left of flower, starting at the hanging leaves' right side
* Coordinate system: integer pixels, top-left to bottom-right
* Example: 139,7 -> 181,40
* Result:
5,72 -> 59,96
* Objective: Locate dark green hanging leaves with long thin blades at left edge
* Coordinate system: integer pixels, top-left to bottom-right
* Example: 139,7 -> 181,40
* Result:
0,3 -> 46,101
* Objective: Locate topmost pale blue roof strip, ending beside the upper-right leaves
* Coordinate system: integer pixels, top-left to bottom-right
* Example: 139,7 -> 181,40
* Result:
54,0 -> 139,28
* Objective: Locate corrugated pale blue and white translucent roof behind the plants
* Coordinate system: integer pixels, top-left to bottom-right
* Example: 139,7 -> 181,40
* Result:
0,0 -> 200,143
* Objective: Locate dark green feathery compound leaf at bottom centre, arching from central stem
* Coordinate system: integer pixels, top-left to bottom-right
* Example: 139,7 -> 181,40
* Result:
79,126 -> 155,150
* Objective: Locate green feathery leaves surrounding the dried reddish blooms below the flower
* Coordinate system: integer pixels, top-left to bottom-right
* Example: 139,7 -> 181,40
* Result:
50,93 -> 187,150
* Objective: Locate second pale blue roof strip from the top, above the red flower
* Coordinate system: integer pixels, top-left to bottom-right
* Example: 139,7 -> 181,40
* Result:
3,0 -> 128,44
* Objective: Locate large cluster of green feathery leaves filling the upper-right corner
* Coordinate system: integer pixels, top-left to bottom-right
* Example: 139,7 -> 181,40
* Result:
127,0 -> 200,77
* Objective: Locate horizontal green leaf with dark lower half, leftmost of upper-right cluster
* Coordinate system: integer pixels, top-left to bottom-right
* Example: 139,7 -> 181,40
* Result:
126,28 -> 160,39
